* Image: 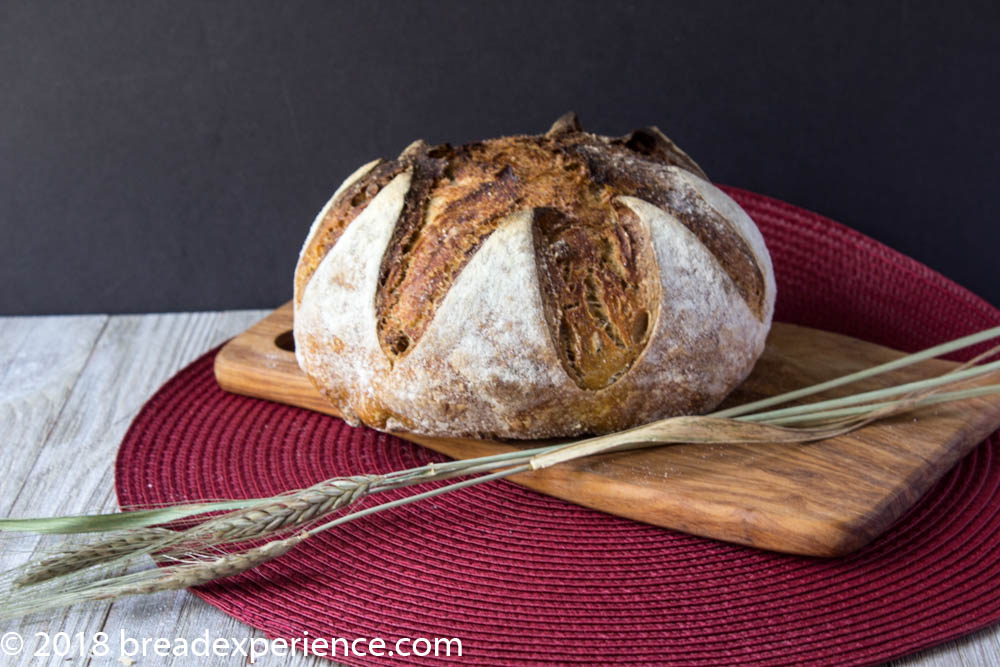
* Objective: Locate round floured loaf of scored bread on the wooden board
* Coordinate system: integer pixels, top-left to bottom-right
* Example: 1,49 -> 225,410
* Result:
295,114 -> 775,438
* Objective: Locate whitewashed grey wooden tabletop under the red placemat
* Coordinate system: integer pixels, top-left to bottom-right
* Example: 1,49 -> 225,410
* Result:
0,310 -> 1000,667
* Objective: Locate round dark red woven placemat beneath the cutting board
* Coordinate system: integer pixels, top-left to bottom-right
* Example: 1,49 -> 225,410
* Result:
116,188 -> 1000,665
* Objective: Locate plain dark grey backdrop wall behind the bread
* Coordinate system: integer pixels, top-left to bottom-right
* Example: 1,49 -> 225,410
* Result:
0,0 -> 1000,313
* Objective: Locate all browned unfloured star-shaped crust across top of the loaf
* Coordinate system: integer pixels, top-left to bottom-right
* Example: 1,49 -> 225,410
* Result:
296,114 -> 765,389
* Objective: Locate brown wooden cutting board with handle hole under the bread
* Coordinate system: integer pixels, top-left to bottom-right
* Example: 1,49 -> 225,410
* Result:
215,303 -> 1000,556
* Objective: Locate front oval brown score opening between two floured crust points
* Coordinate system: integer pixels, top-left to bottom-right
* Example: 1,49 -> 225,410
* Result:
532,207 -> 660,390
